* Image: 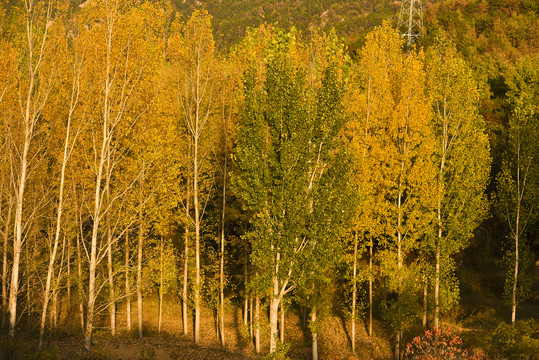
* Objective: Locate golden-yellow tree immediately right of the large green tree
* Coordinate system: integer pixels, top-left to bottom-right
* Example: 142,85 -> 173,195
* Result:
352,23 -> 435,359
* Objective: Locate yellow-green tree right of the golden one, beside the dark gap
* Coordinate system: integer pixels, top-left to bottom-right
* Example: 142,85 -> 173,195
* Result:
426,35 -> 490,329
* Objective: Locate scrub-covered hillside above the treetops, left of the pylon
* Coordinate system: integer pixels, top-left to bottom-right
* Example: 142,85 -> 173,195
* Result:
173,0 -> 400,49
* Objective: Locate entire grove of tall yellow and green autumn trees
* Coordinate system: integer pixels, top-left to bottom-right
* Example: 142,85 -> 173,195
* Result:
0,0 -> 539,359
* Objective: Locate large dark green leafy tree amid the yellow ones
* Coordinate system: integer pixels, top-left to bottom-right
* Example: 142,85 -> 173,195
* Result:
234,28 -> 352,353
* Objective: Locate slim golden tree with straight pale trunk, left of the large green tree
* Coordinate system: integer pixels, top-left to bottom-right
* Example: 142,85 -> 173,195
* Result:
170,11 -> 216,344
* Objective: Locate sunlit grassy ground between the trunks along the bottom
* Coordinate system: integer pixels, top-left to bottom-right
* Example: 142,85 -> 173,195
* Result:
33,298 -> 391,360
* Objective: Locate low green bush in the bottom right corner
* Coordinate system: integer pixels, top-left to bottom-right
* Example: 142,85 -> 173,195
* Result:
491,319 -> 539,360
